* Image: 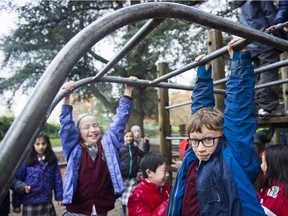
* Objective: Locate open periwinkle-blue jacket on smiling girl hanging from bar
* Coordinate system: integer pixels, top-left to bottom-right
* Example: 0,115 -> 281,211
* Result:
59,96 -> 132,204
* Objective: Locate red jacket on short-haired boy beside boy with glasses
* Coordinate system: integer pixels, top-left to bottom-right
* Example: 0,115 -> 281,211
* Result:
128,178 -> 170,216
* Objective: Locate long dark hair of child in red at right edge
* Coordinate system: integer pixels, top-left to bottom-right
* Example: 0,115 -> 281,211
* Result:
263,144 -> 288,195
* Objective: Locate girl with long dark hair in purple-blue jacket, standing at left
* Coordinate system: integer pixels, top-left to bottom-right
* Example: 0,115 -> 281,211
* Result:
12,133 -> 63,216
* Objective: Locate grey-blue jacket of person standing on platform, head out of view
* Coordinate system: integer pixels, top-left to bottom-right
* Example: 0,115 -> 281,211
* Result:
239,0 -> 285,57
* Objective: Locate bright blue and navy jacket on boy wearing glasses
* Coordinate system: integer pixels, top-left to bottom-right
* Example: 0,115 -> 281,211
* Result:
167,52 -> 265,216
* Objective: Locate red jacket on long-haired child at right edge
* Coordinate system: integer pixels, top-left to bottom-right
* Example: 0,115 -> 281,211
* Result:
257,184 -> 288,216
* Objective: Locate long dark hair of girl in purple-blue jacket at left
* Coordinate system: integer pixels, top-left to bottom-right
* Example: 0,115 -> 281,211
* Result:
26,132 -> 57,166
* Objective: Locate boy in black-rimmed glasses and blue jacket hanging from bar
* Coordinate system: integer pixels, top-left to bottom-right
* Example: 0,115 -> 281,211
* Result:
167,39 -> 265,216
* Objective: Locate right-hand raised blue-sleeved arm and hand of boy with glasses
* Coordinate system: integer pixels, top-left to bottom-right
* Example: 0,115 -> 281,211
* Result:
224,40 -> 259,181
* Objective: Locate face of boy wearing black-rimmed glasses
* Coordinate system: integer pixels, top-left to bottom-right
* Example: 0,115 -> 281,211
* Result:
189,126 -> 222,161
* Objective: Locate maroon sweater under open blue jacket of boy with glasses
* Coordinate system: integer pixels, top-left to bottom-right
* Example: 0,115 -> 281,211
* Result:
181,160 -> 200,216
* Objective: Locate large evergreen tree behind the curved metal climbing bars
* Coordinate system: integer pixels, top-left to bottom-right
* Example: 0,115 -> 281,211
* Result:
0,0 -> 241,128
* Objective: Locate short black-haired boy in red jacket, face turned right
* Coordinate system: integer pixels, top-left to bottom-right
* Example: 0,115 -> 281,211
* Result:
128,152 -> 170,216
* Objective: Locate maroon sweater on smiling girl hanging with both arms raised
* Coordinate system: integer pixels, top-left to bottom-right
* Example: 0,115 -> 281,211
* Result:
66,142 -> 116,215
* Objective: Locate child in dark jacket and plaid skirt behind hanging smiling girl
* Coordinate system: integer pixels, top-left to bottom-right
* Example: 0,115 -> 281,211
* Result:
119,131 -> 144,216
